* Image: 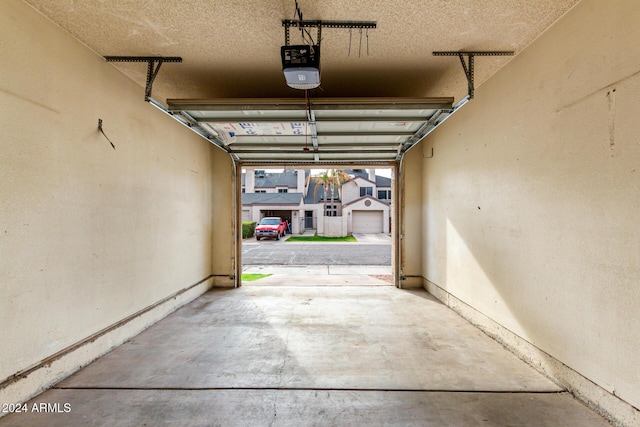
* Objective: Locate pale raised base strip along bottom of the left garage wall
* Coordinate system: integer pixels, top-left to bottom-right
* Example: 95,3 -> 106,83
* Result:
0,276 -> 213,417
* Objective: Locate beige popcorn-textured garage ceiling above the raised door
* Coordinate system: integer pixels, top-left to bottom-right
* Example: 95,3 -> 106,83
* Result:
26,0 -> 579,101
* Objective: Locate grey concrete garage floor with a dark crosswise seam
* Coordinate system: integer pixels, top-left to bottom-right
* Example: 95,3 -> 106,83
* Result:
0,279 -> 609,427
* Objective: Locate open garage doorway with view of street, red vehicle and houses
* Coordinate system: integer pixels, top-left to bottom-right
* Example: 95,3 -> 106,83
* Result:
237,166 -> 396,286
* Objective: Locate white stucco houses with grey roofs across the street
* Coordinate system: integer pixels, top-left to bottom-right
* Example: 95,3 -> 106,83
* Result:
242,169 -> 392,236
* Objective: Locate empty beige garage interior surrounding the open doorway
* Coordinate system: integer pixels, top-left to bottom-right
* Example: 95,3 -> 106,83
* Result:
0,0 -> 640,426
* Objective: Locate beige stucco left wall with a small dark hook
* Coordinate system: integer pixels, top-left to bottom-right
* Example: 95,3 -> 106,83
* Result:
0,0 -> 219,402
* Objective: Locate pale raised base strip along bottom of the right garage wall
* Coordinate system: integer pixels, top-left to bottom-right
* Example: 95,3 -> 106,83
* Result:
423,277 -> 640,426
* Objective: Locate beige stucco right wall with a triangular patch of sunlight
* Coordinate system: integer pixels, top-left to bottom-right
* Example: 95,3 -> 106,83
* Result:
416,0 -> 640,418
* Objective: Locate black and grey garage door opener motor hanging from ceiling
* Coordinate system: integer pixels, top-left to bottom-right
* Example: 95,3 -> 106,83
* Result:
280,45 -> 320,90
